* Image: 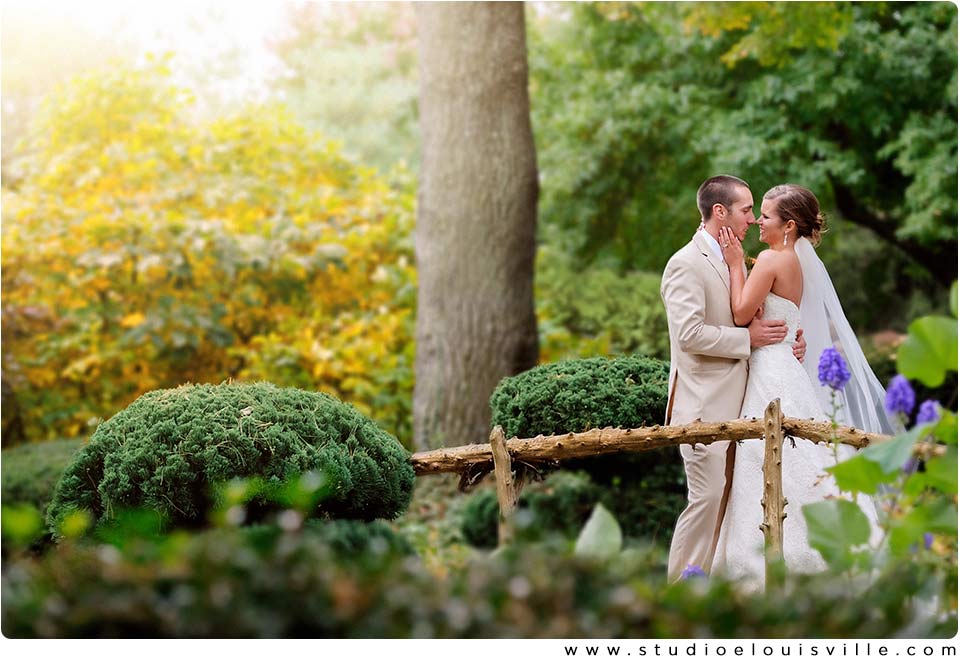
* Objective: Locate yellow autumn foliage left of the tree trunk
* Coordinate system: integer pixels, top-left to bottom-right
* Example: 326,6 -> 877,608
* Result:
2,61 -> 416,443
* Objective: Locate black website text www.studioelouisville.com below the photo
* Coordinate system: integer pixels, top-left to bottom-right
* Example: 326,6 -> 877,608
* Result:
562,641 -> 957,659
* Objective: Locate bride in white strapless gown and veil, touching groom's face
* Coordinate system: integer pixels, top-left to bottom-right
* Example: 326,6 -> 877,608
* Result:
711,184 -> 893,590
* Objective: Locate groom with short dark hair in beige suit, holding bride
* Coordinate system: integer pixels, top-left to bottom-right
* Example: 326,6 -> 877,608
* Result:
660,175 -> 806,581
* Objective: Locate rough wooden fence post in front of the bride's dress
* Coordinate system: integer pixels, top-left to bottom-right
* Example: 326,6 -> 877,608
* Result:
760,399 -> 787,590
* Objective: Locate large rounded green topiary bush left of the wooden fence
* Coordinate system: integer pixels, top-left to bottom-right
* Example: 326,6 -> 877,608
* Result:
47,383 -> 414,528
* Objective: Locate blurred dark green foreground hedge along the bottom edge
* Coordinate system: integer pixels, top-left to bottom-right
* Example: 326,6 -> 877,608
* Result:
2,528 -> 956,639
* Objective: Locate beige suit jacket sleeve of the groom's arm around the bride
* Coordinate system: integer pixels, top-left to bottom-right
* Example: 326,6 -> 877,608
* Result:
660,255 -> 750,360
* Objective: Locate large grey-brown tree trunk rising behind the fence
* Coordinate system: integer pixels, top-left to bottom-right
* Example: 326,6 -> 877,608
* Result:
413,2 -> 538,450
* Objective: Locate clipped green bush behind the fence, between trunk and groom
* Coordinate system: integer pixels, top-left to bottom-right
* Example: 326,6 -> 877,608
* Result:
492,355 -> 686,542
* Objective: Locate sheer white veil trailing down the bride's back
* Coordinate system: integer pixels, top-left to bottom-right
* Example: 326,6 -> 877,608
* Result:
794,237 -> 902,435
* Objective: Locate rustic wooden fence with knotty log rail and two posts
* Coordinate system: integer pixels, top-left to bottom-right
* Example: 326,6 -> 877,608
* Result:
410,399 -> 943,588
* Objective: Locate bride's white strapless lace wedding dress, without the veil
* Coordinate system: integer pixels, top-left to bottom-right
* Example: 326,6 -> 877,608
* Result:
711,293 -> 880,590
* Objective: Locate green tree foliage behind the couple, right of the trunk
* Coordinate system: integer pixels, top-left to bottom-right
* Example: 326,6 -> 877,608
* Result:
531,3 -> 957,329
